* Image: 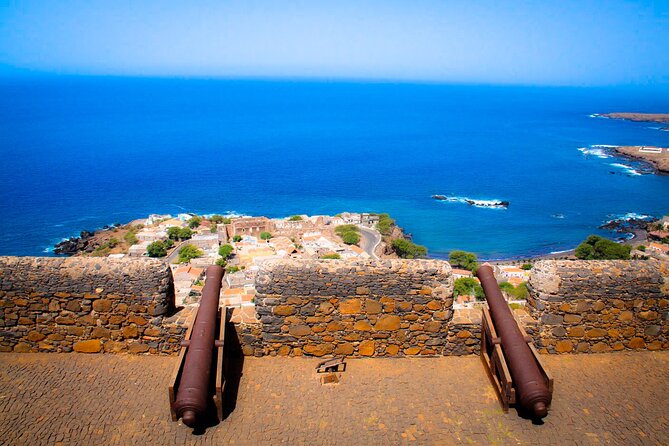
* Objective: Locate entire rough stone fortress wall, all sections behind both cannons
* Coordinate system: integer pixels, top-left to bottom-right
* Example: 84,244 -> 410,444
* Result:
0,257 -> 669,357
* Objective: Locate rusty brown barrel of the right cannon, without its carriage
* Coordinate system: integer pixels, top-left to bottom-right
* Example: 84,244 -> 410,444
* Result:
476,265 -> 551,419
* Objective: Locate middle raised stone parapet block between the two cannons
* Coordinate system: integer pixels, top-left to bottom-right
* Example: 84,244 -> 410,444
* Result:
256,260 -> 454,356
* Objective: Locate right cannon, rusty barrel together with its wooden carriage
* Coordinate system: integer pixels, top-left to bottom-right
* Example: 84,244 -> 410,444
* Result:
476,264 -> 553,420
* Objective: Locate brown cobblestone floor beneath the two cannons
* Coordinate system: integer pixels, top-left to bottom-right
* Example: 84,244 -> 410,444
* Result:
0,352 -> 669,446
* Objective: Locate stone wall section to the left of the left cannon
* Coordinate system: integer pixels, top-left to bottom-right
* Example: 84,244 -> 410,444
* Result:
0,257 -> 186,354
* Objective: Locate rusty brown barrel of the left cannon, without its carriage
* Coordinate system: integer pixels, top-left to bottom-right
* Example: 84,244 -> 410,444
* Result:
174,266 -> 224,427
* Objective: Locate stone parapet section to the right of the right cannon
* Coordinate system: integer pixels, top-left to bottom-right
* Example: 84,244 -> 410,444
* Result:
528,260 -> 669,353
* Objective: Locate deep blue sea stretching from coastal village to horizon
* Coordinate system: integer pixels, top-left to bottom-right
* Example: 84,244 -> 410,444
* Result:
0,77 -> 669,258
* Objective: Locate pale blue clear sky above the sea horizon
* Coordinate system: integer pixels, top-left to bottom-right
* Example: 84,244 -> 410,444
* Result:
0,0 -> 669,86
